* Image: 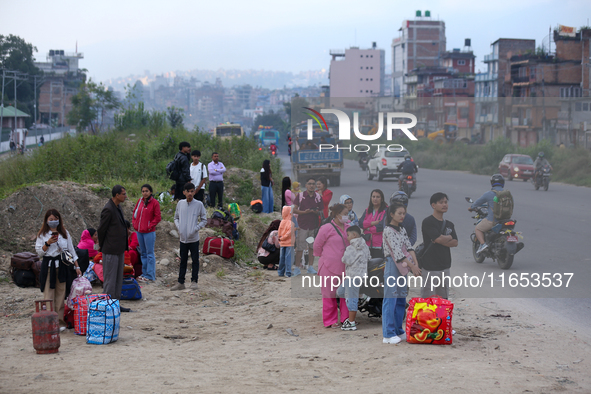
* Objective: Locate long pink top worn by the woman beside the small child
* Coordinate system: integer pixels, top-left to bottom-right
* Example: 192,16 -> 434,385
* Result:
314,221 -> 349,276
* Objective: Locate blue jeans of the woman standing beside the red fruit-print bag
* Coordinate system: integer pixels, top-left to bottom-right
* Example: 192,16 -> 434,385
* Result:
382,256 -> 408,338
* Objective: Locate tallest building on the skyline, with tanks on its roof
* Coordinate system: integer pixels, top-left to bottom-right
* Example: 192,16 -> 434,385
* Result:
392,11 -> 446,97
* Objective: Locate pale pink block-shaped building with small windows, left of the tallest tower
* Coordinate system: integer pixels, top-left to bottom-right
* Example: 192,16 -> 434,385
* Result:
328,42 -> 386,97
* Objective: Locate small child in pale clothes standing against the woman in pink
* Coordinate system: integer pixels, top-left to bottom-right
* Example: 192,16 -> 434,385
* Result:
337,226 -> 371,331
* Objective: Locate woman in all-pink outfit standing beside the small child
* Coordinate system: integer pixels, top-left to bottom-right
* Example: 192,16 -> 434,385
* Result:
314,204 -> 349,328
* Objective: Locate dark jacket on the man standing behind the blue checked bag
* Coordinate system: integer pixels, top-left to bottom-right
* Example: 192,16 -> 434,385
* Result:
96,199 -> 127,255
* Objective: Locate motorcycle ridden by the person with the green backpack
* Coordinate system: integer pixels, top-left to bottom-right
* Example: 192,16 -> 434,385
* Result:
466,197 -> 525,270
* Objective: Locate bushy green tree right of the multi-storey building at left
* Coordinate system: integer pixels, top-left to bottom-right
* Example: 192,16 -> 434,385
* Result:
68,79 -> 120,134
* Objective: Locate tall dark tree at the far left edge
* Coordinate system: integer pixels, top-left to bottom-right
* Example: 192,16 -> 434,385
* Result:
0,34 -> 42,124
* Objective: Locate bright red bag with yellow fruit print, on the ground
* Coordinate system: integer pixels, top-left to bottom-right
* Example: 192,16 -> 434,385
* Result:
406,296 -> 454,345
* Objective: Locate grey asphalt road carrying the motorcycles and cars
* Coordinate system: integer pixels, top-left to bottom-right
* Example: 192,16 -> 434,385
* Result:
281,156 -> 591,327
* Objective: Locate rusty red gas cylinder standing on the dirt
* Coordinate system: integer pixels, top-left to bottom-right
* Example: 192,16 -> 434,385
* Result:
31,300 -> 60,354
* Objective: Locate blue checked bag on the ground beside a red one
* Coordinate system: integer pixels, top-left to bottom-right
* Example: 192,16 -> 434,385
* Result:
86,299 -> 121,345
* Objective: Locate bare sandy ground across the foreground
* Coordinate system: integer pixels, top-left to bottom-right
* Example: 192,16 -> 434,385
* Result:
0,263 -> 591,393
